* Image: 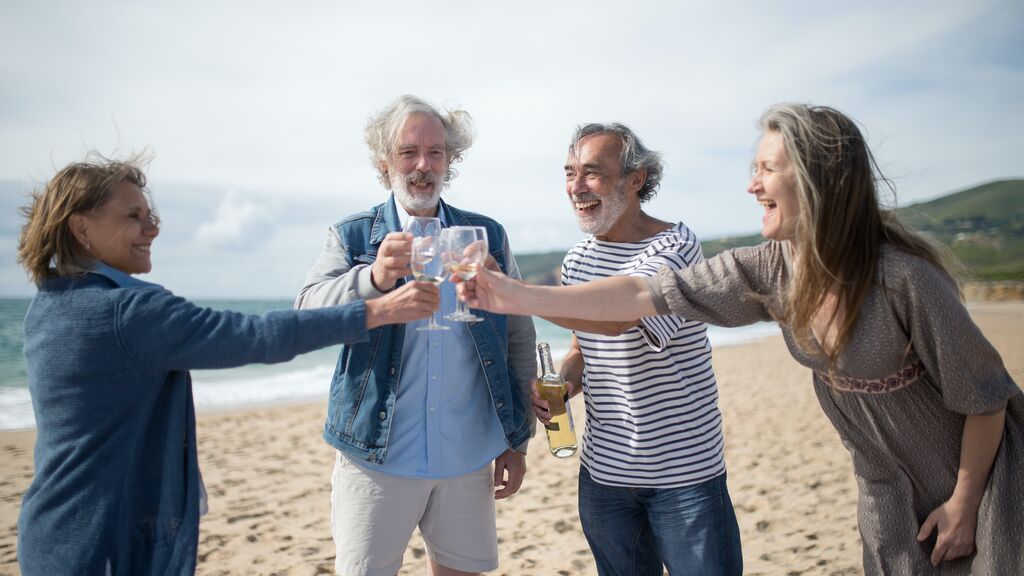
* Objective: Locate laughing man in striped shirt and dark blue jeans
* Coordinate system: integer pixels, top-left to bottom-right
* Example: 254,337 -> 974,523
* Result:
534,124 -> 742,576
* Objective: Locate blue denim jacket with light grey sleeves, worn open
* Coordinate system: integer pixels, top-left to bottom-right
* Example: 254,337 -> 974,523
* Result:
295,197 -> 537,463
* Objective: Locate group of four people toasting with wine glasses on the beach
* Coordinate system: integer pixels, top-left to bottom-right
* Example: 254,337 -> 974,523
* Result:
12,91 -> 1024,576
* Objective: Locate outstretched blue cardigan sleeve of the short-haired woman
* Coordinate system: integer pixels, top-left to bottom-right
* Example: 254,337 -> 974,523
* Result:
117,289 -> 368,370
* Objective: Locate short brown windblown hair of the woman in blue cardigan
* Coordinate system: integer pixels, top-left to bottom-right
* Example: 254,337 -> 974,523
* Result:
17,153 -> 160,286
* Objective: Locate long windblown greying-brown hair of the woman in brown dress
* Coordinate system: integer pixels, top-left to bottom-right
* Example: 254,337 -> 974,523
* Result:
759,104 -> 958,364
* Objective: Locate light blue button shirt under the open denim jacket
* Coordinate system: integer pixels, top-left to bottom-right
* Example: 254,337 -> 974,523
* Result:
353,202 -> 508,479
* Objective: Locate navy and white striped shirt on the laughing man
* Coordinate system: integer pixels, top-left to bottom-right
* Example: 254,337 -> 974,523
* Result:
562,222 -> 725,488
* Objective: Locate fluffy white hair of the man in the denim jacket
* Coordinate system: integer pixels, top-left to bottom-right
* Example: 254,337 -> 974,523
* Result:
364,94 -> 473,190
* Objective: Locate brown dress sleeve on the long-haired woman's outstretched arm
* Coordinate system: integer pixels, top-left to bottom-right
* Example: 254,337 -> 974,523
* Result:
649,242 -> 783,327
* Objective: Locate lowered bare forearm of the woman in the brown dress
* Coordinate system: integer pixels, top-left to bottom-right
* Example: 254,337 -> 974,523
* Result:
953,408 -> 1007,506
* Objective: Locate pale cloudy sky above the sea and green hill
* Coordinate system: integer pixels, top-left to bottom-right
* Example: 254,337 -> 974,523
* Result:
0,0 -> 1024,298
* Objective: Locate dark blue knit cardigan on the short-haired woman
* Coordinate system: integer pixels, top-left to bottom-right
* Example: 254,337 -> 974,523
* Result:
17,264 -> 367,576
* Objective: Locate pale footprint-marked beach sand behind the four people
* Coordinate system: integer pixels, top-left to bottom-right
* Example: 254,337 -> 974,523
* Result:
0,302 -> 1024,576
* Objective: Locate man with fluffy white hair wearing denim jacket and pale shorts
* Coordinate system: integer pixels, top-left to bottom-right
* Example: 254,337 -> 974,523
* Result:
295,95 -> 537,576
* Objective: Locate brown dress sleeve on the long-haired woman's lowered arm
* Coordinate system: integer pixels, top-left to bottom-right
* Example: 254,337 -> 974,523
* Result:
884,252 -> 1020,414
